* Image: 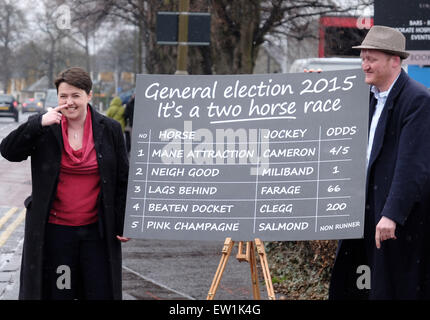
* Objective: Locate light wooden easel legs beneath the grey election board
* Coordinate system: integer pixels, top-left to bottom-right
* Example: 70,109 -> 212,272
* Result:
206,238 -> 275,300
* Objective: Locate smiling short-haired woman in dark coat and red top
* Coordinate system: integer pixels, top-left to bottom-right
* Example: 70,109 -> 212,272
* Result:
0,68 -> 128,299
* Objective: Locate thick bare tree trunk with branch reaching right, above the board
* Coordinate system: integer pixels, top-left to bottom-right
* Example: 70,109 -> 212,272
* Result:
210,0 -> 371,73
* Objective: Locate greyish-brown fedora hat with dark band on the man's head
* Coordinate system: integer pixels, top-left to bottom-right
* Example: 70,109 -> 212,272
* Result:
352,26 -> 409,59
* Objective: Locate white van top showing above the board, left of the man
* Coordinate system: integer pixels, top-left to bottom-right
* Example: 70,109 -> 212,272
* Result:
290,58 -> 361,73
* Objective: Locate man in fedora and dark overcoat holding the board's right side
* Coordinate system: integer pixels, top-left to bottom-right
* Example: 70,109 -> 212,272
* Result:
329,26 -> 430,299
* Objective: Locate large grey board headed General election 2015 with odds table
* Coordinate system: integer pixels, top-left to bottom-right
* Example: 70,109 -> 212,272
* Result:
124,69 -> 368,241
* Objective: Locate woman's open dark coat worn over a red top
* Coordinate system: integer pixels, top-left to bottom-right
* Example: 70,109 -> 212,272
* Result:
0,107 -> 128,299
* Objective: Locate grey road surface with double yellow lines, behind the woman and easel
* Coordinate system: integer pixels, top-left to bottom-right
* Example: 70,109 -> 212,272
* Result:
0,115 -> 267,300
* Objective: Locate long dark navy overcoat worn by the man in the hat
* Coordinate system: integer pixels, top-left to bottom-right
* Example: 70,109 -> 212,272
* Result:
330,70 -> 430,299
